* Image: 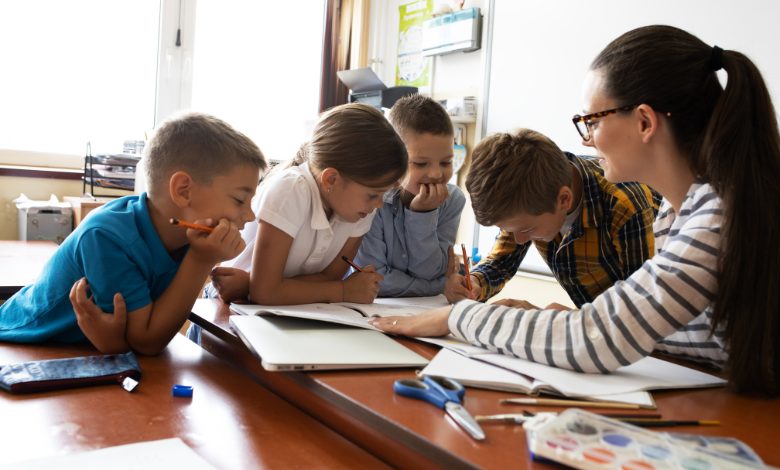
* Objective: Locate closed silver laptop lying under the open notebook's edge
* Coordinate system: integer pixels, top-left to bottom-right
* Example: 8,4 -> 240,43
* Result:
230,315 -> 428,370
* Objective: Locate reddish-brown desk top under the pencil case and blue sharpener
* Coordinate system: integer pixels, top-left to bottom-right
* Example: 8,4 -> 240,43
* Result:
0,335 -> 384,468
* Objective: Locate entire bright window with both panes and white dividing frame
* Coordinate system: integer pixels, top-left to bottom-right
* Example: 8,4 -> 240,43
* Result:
0,0 -> 325,167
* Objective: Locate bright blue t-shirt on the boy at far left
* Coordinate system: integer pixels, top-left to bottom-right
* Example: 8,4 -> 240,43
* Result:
0,193 -> 186,343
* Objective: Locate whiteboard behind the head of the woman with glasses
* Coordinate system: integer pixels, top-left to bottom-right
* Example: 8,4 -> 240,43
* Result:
487,0 -> 780,153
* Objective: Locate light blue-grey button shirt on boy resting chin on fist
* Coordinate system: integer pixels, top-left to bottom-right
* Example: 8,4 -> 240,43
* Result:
355,184 -> 466,297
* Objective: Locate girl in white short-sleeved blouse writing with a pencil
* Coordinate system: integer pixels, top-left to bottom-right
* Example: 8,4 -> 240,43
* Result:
212,103 -> 408,305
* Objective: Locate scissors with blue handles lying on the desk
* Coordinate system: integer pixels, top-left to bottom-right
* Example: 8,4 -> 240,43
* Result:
393,375 -> 485,441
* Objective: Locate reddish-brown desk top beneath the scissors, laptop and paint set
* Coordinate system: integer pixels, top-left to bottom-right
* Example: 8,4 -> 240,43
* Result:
190,299 -> 780,468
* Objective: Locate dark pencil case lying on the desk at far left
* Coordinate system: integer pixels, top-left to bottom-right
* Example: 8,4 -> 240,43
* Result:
0,351 -> 141,393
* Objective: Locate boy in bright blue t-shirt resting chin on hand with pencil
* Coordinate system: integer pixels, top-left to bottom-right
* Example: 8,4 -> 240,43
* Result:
0,113 -> 266,354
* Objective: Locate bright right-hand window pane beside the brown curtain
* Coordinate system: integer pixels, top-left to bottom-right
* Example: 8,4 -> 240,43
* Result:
191,0 -> 325,160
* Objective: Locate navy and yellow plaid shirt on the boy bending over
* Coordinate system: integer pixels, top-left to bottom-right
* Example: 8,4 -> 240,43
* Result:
472,153 -> 661,307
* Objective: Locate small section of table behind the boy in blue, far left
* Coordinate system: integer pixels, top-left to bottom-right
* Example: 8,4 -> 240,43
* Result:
0,240 -> 59,300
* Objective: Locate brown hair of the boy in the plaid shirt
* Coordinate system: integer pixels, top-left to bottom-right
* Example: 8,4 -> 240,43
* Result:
466,129 -> 572,225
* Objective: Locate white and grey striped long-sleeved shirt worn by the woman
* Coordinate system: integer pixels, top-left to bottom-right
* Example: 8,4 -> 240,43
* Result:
449,183 -> 727,373
